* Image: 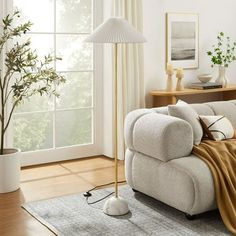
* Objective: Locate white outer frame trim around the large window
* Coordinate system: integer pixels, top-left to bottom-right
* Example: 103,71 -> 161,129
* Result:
0,0 -> 103,166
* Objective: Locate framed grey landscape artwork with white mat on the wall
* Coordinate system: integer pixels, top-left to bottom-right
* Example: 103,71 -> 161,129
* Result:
166,13 -> 199,69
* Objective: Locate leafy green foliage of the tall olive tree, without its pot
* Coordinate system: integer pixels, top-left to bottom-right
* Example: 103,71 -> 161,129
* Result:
0,11 -> 65,149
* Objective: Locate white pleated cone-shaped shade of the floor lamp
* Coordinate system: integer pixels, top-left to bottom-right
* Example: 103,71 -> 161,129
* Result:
85,17 -> 146,43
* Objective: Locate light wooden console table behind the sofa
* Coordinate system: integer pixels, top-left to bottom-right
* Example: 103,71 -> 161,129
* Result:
150,85 -> 236,107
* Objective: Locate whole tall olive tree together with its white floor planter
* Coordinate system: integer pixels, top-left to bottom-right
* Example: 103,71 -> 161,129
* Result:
0,11 -> 65,193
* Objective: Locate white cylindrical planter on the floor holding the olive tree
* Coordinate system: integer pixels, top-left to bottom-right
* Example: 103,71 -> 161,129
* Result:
0,148 -> 21,193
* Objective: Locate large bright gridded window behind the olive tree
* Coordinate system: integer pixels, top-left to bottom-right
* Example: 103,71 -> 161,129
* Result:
8,0 -> 101,164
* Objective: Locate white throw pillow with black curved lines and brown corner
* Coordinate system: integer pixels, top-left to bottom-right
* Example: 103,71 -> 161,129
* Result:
199,116 -> 234,141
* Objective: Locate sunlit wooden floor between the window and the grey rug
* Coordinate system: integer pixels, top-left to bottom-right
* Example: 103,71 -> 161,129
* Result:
0,156 -> 125,236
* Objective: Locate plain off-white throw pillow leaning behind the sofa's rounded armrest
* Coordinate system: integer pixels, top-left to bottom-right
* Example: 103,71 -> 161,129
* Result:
168,100 -> 203,145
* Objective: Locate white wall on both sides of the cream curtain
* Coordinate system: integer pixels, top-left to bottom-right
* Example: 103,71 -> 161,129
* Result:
103,0 -> 236,157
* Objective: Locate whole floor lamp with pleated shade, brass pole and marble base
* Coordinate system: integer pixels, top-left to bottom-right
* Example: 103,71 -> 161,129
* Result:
85,17 -> 146,216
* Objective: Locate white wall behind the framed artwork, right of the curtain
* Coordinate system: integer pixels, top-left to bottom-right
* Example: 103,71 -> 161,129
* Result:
143,0 -> 236,106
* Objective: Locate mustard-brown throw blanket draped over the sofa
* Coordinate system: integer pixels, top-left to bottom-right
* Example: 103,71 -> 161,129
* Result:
193,139 -> 236,235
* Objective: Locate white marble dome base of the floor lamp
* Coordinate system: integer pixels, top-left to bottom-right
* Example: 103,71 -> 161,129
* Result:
103,197 -> 129,216
